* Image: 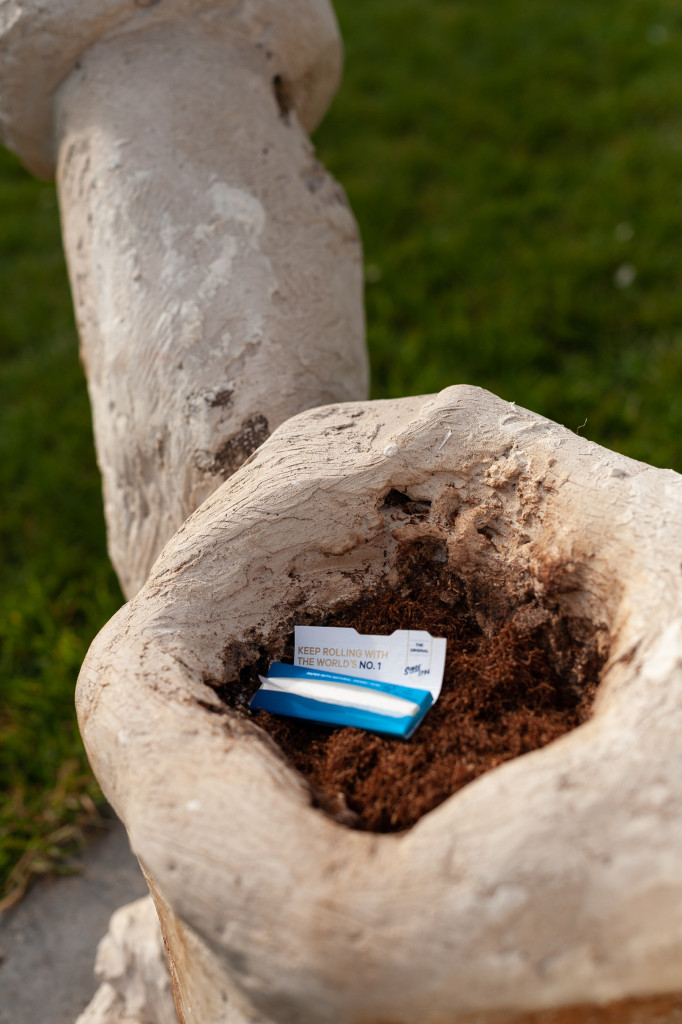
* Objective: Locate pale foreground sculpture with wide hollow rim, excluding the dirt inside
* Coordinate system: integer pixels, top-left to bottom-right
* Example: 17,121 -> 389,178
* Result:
77,387 -> 682,1024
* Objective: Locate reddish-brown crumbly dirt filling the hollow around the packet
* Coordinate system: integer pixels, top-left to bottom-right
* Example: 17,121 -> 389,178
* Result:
221,559 -> 606,833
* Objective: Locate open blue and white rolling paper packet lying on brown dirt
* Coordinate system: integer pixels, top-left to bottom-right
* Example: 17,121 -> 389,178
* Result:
250,626 -> 445,739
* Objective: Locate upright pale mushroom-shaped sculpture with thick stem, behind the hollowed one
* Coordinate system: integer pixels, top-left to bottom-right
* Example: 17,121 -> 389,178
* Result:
0,0 -> 368,596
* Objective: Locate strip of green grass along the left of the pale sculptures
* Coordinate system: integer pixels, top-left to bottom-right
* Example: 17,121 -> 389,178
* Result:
0,153 -> 121,899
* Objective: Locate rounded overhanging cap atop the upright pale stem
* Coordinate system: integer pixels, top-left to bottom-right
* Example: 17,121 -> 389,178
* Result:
0,0 -> 342,178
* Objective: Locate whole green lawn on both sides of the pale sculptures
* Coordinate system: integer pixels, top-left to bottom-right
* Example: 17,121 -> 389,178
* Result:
0,0 -> 682,891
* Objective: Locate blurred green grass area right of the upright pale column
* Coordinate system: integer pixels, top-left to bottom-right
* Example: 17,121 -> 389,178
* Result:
317,0 -> 682,468
